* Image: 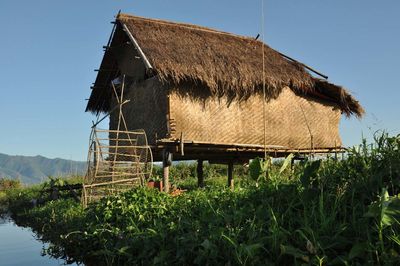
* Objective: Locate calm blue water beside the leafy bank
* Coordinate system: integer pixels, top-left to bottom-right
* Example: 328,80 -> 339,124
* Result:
0,218 -> 76,266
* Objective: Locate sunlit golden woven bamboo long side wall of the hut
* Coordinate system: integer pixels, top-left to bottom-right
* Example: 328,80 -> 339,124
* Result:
170,87 -> 341,149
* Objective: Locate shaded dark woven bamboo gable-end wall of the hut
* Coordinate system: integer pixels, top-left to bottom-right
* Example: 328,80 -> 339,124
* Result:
110,78 -> 168,145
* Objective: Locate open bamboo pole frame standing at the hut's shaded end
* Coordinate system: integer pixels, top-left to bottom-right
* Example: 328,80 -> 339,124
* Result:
82,78 -> 153,206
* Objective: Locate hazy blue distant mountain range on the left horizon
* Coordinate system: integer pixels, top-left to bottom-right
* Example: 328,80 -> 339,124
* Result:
0,153 -> 86,184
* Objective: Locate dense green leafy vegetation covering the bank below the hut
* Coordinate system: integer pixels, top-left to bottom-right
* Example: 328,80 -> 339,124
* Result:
4,134 -> 400,265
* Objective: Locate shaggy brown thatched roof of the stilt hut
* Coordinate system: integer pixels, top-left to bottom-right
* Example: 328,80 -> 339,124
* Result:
87,14 -> 364,116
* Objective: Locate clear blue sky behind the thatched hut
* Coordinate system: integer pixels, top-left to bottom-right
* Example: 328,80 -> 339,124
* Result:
0,0 -> 400,160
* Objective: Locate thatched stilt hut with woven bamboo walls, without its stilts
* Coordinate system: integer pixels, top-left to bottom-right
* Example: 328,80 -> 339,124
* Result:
86,14 -> 364,162
